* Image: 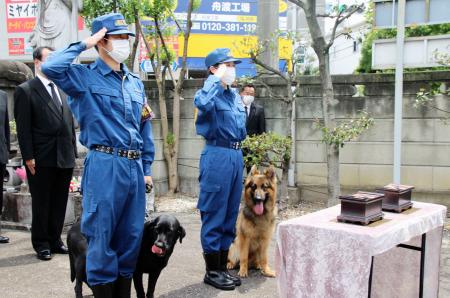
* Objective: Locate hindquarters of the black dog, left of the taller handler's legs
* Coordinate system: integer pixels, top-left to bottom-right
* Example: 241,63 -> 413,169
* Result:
67,221 -> 89,298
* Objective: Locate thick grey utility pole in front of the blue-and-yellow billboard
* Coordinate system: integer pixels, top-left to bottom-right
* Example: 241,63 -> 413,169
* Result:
257,0 -> 279,69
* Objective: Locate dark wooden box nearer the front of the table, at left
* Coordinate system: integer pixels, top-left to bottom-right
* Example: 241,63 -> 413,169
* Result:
337,191 -> 384,225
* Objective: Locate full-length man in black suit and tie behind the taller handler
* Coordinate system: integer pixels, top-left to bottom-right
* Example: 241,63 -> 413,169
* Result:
14,47 -> 77,260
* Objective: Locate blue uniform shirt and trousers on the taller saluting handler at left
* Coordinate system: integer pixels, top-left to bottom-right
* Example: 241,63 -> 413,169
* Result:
42,42 -> 154,286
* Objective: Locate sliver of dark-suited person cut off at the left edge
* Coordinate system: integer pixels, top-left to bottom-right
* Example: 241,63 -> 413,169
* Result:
0,90 -> 9,243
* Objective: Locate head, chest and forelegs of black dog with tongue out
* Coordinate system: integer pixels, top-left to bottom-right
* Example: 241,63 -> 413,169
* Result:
133,214 -> 186,298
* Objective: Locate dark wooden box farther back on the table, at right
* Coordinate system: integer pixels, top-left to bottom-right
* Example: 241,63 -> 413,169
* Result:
377,183 -> 414,212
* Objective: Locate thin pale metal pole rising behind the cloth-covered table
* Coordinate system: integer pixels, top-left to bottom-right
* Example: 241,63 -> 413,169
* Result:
394,0 -> 406,183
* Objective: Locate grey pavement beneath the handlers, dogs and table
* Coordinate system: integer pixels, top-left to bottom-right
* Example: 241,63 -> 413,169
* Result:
0,212 -> 450,298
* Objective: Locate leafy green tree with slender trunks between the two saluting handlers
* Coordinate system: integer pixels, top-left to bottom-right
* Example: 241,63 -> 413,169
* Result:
82,0 -> 201,194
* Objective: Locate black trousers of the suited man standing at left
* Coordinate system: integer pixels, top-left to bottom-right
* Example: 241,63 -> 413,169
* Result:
26,167 -> 73,252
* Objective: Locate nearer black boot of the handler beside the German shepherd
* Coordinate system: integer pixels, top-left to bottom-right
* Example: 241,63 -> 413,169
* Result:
203,252 -> 234,291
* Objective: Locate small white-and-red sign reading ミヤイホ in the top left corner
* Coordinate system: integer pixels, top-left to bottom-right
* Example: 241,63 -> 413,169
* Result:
6,0 -> 38,33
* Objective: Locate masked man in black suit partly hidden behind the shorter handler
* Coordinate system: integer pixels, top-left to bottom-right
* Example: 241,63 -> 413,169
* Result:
239,84 -> 266,174
